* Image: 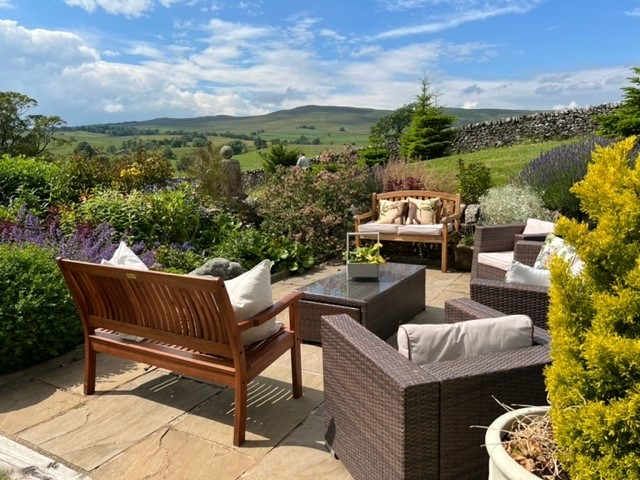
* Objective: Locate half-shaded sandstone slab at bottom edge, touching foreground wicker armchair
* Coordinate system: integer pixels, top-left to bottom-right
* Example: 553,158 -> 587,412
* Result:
240,408 -> 353,480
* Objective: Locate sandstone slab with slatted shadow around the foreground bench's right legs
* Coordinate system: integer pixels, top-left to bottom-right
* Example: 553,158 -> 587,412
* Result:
172,365 -> 323,458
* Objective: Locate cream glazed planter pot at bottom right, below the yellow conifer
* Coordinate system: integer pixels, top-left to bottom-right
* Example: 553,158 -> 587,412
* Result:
484,406 -> 549,480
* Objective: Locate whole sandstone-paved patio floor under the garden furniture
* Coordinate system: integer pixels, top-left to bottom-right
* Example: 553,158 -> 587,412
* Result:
0,265 -> 469,480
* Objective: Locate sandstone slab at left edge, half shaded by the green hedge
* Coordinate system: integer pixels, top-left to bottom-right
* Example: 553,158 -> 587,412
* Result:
0,380 -> 84,435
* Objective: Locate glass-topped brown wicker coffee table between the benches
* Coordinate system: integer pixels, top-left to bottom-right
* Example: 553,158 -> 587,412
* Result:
300,263 -> 426,343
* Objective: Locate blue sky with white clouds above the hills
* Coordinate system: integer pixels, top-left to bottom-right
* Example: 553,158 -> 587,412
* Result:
0,0 -> 640,125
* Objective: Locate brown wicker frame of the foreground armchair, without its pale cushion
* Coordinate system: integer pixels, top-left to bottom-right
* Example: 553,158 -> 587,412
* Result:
322,299 -> 550,480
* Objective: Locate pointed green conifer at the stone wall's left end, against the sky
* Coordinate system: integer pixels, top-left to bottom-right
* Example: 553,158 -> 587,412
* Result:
401,78 -> 456,160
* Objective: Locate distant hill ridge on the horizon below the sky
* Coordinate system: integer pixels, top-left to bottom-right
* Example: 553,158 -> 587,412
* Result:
94,105 -> 537,135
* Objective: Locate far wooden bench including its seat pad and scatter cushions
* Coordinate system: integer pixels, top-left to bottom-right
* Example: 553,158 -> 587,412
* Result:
354,190 -> 461,272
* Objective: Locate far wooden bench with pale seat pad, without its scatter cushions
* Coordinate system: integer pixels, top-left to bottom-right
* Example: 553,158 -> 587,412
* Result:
355,190 -> 461,272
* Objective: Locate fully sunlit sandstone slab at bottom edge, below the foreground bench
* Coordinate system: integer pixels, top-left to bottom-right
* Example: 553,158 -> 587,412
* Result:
90,427 -> 255,480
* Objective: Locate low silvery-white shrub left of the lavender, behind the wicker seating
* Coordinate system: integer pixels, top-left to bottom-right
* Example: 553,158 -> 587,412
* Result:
479,185 -> 552,225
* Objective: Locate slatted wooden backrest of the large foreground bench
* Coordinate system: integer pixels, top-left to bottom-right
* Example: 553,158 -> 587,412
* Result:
58,259 -> 240,358
